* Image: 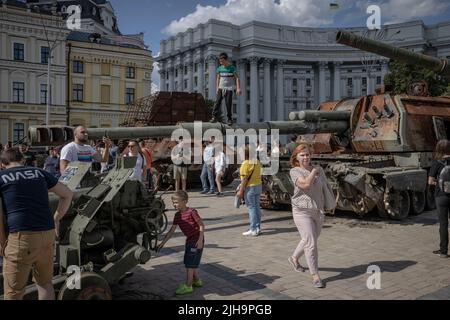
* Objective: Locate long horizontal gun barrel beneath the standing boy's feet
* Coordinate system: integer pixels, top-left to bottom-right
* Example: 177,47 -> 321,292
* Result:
28,120 -> 349,146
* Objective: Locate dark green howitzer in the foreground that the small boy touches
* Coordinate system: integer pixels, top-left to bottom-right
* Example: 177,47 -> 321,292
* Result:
0,157 -> 167,300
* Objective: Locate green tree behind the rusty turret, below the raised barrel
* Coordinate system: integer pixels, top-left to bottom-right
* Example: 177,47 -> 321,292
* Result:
384,61 -> 450,97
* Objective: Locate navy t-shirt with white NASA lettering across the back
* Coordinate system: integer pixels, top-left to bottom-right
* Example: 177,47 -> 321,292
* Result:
0,167 -> 58,232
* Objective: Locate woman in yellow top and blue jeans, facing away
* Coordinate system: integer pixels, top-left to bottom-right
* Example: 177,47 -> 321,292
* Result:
236,145 -> 262,237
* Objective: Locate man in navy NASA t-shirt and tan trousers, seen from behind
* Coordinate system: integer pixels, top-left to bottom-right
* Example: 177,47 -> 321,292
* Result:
0,148 -> 73,300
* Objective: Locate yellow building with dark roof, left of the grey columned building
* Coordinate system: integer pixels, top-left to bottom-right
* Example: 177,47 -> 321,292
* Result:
67,31 -> 153,127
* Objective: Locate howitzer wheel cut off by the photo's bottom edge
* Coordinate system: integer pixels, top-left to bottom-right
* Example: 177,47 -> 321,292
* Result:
58,272 -> 112,300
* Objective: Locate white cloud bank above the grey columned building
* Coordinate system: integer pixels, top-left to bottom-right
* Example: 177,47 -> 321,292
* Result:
163,0 -> 450,35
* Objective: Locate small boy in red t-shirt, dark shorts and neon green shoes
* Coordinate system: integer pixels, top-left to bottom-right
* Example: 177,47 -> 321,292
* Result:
157,190 -> 205,295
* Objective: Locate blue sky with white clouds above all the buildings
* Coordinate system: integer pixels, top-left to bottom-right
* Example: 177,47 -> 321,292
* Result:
110,0 -> 450,90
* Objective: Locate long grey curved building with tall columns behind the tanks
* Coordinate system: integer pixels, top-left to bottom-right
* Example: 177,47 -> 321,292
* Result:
156,20 -> 450,122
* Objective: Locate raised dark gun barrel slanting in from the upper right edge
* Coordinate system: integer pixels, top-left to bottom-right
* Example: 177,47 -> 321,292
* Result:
336,30 -> 450,76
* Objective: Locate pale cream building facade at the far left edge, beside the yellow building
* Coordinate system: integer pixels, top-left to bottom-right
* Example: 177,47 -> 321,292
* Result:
0,1 -> 69,144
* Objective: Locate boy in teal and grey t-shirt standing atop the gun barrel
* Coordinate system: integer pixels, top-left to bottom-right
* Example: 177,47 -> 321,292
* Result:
210,52 -> 241,125
